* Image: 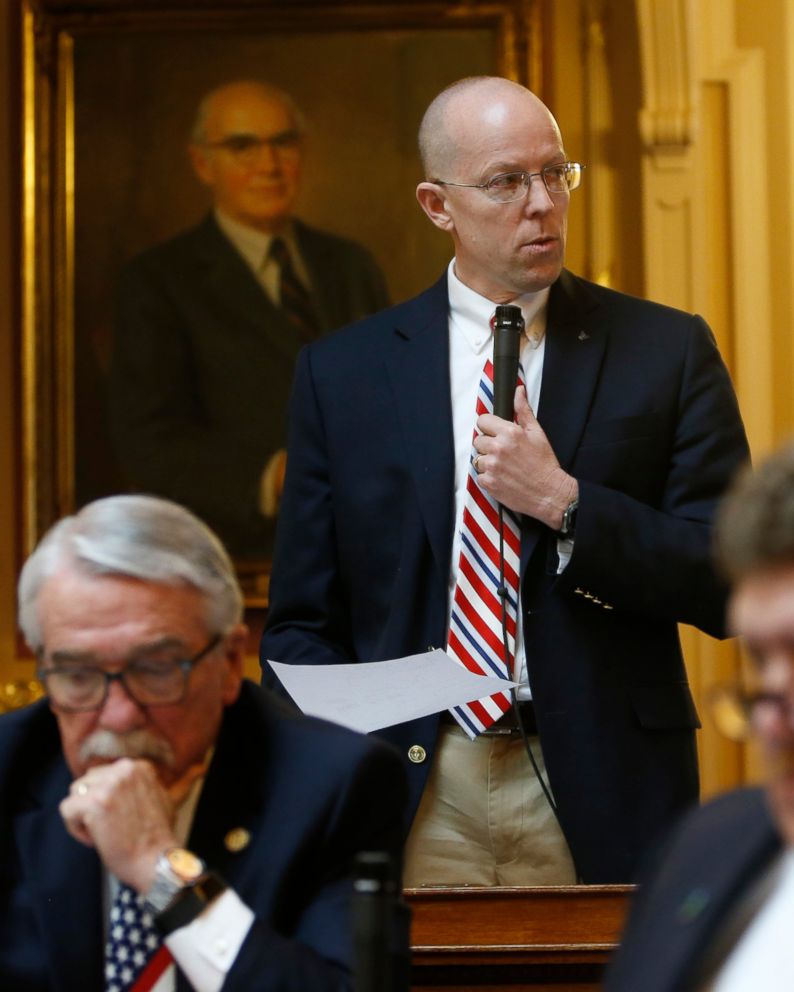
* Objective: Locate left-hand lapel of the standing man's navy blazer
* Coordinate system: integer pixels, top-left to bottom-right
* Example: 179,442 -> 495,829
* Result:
385,275 -> 455,584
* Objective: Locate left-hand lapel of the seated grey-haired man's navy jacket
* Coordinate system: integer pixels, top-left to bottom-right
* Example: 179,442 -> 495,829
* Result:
15,760 -> 104,992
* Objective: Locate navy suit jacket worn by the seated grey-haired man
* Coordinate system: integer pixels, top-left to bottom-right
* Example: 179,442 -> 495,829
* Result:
0,682 -> 407,992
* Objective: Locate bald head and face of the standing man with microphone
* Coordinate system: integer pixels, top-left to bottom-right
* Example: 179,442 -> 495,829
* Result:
416,76 -> 570,303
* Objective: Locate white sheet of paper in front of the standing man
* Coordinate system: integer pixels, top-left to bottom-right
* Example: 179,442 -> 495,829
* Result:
268,648 -> 518,734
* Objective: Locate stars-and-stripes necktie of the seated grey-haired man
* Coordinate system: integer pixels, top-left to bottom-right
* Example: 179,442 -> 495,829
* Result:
105,884 -> 174,992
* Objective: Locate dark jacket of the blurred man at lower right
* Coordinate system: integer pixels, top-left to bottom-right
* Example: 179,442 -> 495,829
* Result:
604,789 -> 782,992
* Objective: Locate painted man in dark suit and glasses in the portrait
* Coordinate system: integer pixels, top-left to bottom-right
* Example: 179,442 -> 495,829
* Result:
110,81 -> 388,558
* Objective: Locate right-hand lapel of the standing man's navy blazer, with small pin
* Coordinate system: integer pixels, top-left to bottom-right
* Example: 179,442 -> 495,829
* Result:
521,271 -> 607,569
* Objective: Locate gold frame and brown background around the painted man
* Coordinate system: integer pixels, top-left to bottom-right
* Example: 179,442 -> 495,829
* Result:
20,0 -> 543,605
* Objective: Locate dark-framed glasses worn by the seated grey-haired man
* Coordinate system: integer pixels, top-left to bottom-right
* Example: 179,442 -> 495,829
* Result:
36,634 -> 222,713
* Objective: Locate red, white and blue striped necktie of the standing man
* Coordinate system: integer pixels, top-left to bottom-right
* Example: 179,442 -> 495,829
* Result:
447,359 -> 521,740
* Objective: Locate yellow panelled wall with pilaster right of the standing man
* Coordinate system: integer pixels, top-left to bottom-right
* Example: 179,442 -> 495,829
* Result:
636,0 -> 794,794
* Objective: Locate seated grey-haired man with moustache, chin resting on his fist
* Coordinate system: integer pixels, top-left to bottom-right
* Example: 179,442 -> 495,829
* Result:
0,497 -> 407,992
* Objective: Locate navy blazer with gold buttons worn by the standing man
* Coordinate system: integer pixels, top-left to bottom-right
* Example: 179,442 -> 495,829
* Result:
262,272 -> 748,882
